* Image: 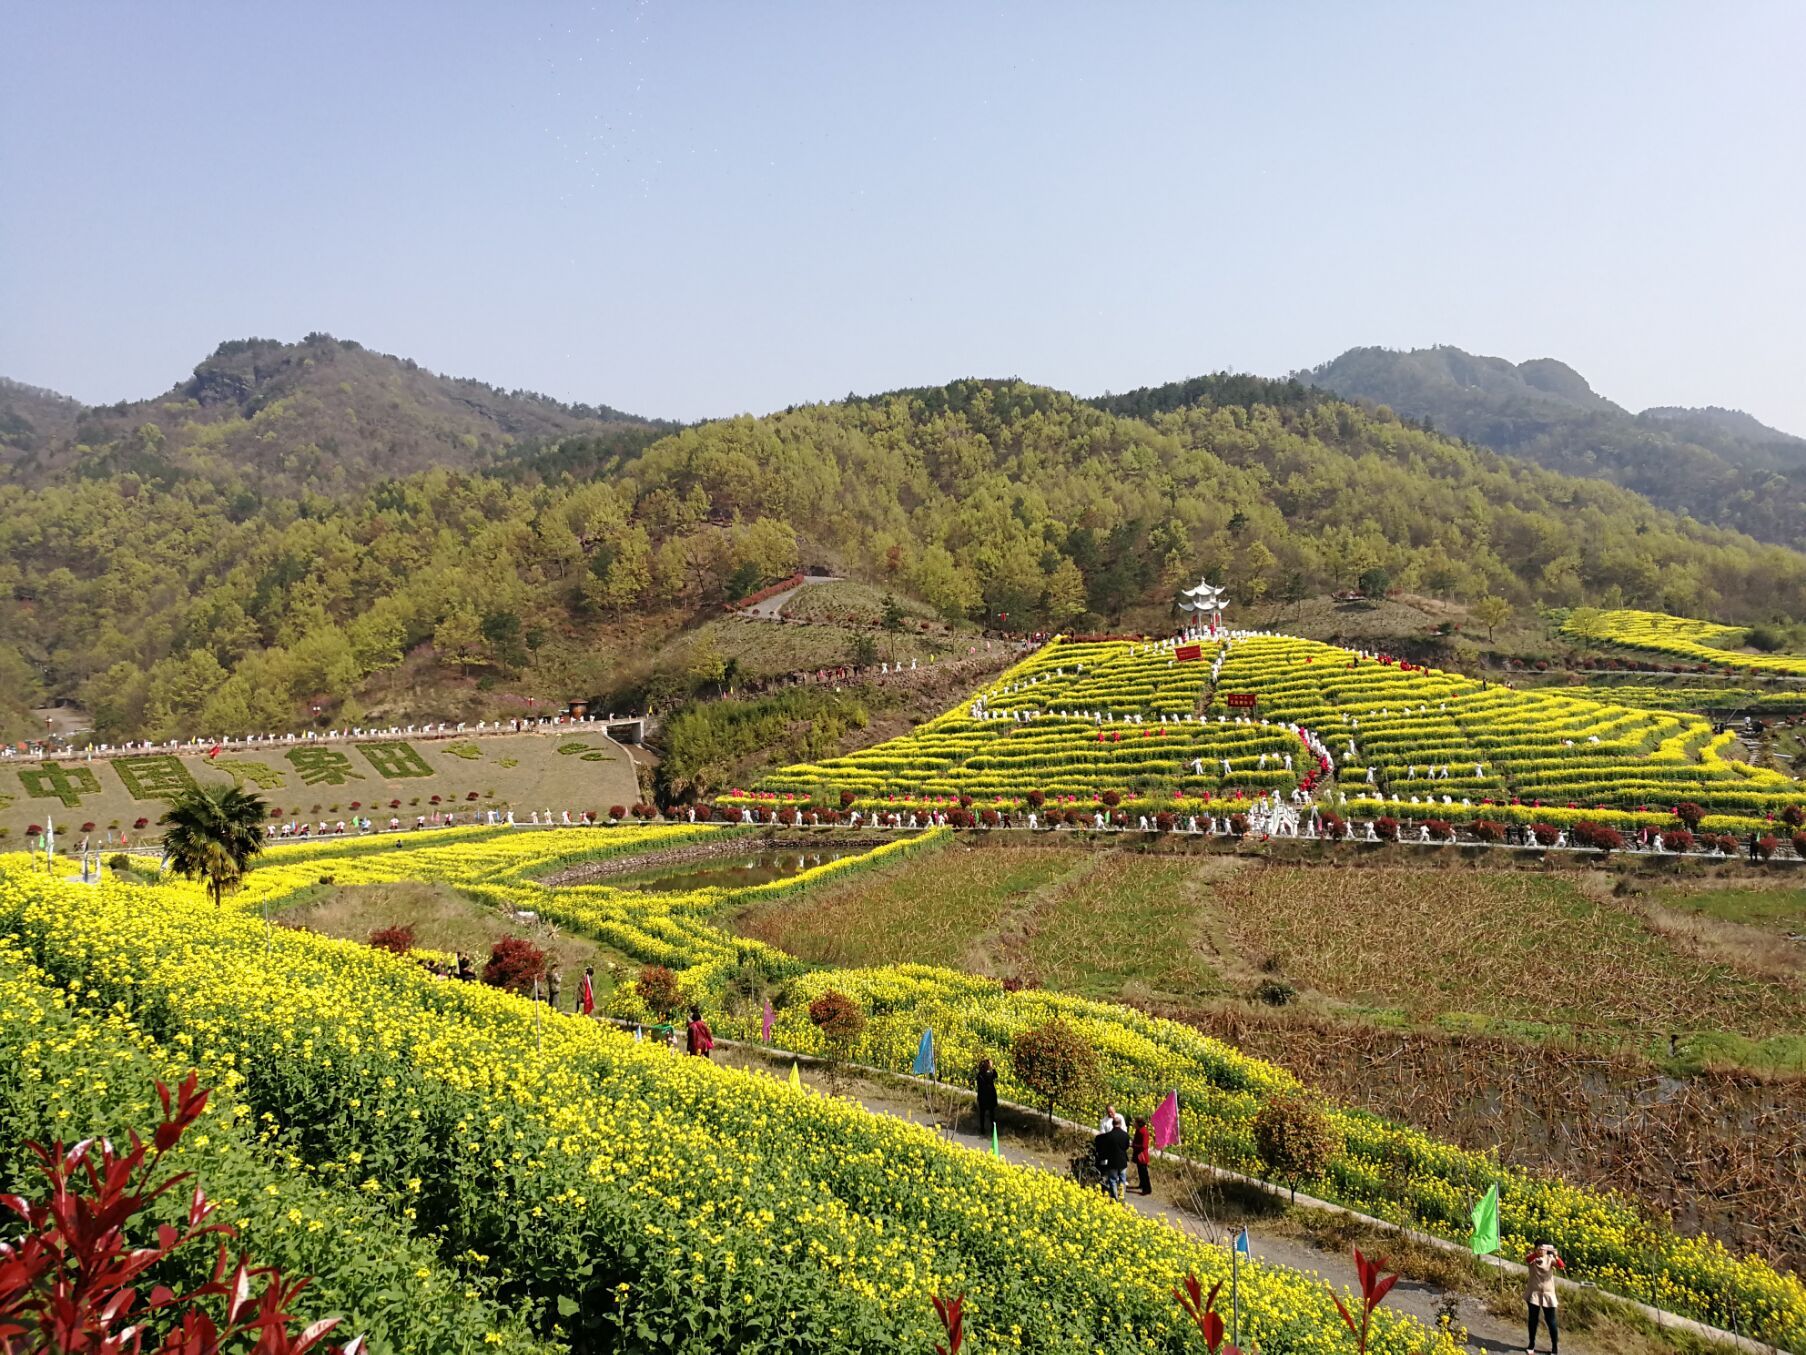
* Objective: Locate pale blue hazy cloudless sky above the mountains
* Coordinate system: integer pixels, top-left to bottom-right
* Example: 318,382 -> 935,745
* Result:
0,0 -> 1806,434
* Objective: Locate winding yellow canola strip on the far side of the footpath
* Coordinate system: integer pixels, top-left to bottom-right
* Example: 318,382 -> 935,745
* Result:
13,827 -> 1806,1346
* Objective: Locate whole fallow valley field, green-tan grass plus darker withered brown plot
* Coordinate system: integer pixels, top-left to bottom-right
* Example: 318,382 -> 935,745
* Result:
735,846 -> 1806,1266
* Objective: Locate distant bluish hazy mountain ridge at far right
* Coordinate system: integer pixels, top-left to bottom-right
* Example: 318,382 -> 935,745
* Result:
1299,347 -> 1806,546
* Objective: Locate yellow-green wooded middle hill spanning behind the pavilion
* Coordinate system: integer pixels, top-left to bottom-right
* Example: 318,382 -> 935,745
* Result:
0,366 -> 1806,735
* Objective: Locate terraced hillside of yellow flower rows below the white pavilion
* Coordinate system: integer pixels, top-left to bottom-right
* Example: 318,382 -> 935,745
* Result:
740,636 -> 1802,827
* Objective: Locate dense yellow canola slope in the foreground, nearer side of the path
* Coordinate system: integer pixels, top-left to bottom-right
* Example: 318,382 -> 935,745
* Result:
0,859 -> 1454,1355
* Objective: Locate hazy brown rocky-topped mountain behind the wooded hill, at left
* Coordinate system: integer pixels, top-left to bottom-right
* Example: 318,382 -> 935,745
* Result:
0,334 -> 664,495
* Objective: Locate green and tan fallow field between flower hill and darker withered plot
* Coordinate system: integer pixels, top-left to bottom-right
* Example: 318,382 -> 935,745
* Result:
739,847 -> 1806,1068
